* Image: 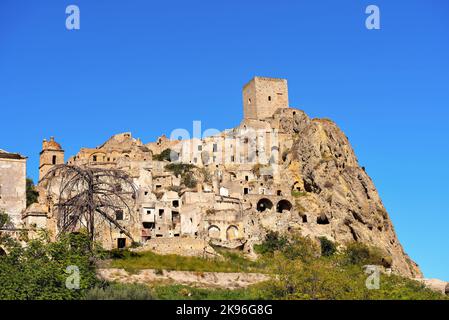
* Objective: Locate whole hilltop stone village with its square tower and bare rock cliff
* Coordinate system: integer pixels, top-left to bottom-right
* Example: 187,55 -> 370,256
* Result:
0,77 -> 421,277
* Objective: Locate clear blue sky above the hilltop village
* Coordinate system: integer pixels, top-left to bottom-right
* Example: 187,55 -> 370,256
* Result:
0,0 -> 449,280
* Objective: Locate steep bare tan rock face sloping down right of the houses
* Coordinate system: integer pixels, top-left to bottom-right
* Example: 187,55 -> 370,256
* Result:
283,112 -> 422,278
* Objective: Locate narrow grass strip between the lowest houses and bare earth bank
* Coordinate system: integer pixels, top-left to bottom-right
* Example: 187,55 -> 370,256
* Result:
109,249 -> 263,273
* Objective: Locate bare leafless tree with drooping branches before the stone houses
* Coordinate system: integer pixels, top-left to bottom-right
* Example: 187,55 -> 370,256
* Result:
43,164 -> 137,243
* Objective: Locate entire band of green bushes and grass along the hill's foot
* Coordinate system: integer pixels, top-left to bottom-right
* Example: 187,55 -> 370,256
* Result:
0,209 -> 448,300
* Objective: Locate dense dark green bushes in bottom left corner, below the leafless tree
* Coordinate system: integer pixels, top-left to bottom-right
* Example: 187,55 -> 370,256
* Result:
0,233 -> 98,300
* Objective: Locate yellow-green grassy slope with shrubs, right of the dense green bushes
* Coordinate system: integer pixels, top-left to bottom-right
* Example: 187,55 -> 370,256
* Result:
103,233 -> 448,300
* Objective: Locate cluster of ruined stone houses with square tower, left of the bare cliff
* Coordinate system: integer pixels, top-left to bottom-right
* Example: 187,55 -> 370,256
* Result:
22,77 -> 295,248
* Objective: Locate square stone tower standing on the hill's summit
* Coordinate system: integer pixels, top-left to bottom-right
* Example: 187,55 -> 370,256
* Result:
243,77 -> 288,120
